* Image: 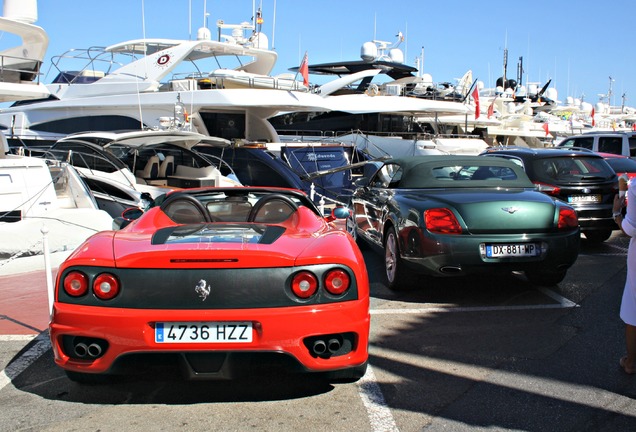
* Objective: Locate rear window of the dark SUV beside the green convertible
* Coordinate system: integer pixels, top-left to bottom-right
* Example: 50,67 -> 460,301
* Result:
532,156 -> 615,183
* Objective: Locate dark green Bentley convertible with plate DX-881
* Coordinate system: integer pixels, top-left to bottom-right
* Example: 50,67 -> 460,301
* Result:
347,155 -> 580,289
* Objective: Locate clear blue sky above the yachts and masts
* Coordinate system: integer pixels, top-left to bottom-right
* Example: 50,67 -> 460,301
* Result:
23,0 -> 636,106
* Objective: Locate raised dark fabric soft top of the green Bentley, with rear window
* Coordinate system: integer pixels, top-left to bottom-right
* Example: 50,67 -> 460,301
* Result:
385,155 -> 534,189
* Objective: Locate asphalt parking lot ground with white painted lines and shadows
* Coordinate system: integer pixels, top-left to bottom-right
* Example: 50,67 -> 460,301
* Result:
0,233 -> 636,431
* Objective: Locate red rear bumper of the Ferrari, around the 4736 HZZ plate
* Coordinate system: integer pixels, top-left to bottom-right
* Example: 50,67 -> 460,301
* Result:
49,300 -> 370,373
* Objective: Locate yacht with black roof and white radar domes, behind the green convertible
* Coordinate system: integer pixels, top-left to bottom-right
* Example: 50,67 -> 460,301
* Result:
271,35 -> 487,157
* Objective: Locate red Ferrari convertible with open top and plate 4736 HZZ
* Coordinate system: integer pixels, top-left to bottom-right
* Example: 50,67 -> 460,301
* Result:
50,187 -> 370,382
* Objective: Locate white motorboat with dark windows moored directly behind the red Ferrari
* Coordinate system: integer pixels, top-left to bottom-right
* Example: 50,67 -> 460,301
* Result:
41,130 -> 240,217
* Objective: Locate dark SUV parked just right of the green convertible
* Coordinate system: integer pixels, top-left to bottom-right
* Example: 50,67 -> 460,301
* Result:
482,147 -> 619,243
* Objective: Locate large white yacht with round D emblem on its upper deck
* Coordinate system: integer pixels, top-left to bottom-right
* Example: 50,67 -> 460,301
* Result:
0,12 -> 327,147
